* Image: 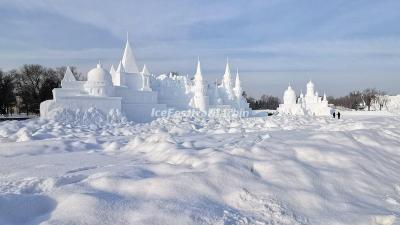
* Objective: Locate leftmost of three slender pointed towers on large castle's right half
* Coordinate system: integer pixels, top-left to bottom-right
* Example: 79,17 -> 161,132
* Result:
193,60 -> 208,112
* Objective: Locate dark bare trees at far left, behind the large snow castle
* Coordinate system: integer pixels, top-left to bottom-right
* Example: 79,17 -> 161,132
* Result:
0,64 -> 82,115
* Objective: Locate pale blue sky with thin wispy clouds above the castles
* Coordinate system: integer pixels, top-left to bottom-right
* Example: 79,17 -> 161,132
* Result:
0,0 -> 400,96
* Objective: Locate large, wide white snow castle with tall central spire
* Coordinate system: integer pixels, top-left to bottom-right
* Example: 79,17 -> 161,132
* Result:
40,35 -> 251,122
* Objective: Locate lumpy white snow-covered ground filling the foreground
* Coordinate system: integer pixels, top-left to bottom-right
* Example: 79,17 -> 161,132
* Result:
0,112 -> 400,225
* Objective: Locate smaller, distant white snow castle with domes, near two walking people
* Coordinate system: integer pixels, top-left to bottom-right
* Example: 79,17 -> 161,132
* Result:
278,80 -> 331,116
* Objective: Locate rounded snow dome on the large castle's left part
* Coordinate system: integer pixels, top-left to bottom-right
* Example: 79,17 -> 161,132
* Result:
84,63 -> 113,96
